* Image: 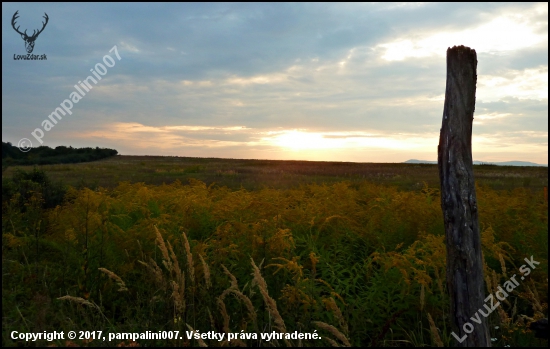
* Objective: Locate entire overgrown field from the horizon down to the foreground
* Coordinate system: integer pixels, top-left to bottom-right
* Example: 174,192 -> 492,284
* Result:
2,156 -> 548,346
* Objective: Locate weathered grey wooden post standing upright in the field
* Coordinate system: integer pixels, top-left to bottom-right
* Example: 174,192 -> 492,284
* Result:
437,46 -> 491,347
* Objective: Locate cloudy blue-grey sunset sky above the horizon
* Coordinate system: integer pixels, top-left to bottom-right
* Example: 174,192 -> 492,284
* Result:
2,3 -> 548,164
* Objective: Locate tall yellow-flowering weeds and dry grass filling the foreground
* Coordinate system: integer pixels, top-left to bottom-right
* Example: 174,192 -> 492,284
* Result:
3,162 -> 547,346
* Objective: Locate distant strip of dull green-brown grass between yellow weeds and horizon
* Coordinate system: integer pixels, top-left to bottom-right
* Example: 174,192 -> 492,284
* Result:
3,155 -> 548,190
